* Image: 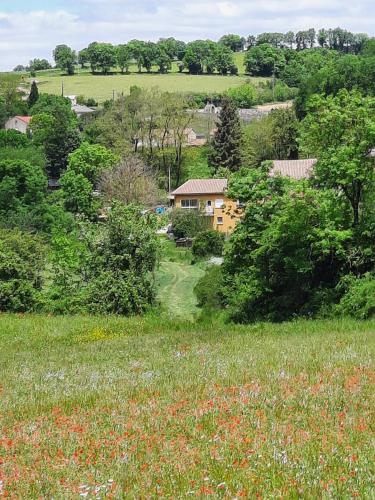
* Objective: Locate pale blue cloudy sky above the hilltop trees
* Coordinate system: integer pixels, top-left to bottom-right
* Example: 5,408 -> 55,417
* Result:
0,0 -> 375,70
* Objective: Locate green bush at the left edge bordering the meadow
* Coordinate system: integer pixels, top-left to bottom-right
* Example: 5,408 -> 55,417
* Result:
0,229 -> 44,312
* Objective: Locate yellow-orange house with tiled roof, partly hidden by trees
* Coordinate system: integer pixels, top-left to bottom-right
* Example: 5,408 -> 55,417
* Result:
171,179 -> 241,235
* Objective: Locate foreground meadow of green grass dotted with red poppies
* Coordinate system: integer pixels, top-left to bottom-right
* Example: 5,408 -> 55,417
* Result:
0,313 -> 375,498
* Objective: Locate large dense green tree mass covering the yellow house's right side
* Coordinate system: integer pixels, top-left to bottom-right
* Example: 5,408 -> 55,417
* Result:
223,165 -> 353,322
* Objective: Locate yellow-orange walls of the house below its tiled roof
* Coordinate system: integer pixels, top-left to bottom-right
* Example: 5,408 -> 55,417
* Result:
175,193 -> 241,235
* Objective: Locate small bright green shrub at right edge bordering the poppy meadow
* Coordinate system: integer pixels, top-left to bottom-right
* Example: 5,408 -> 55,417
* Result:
337,273 -> 375,319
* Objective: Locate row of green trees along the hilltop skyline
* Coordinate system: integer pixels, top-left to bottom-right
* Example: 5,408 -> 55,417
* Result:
14,28 -> 369,75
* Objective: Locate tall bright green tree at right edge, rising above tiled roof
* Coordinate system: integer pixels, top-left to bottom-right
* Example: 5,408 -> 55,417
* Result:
300,90 -> 375,226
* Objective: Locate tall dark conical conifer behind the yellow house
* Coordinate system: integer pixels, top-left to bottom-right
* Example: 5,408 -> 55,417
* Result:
209,97 -> 242,172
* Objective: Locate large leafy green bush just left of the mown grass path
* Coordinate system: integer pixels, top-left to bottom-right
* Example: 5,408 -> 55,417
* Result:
88,204 -> 158,315
